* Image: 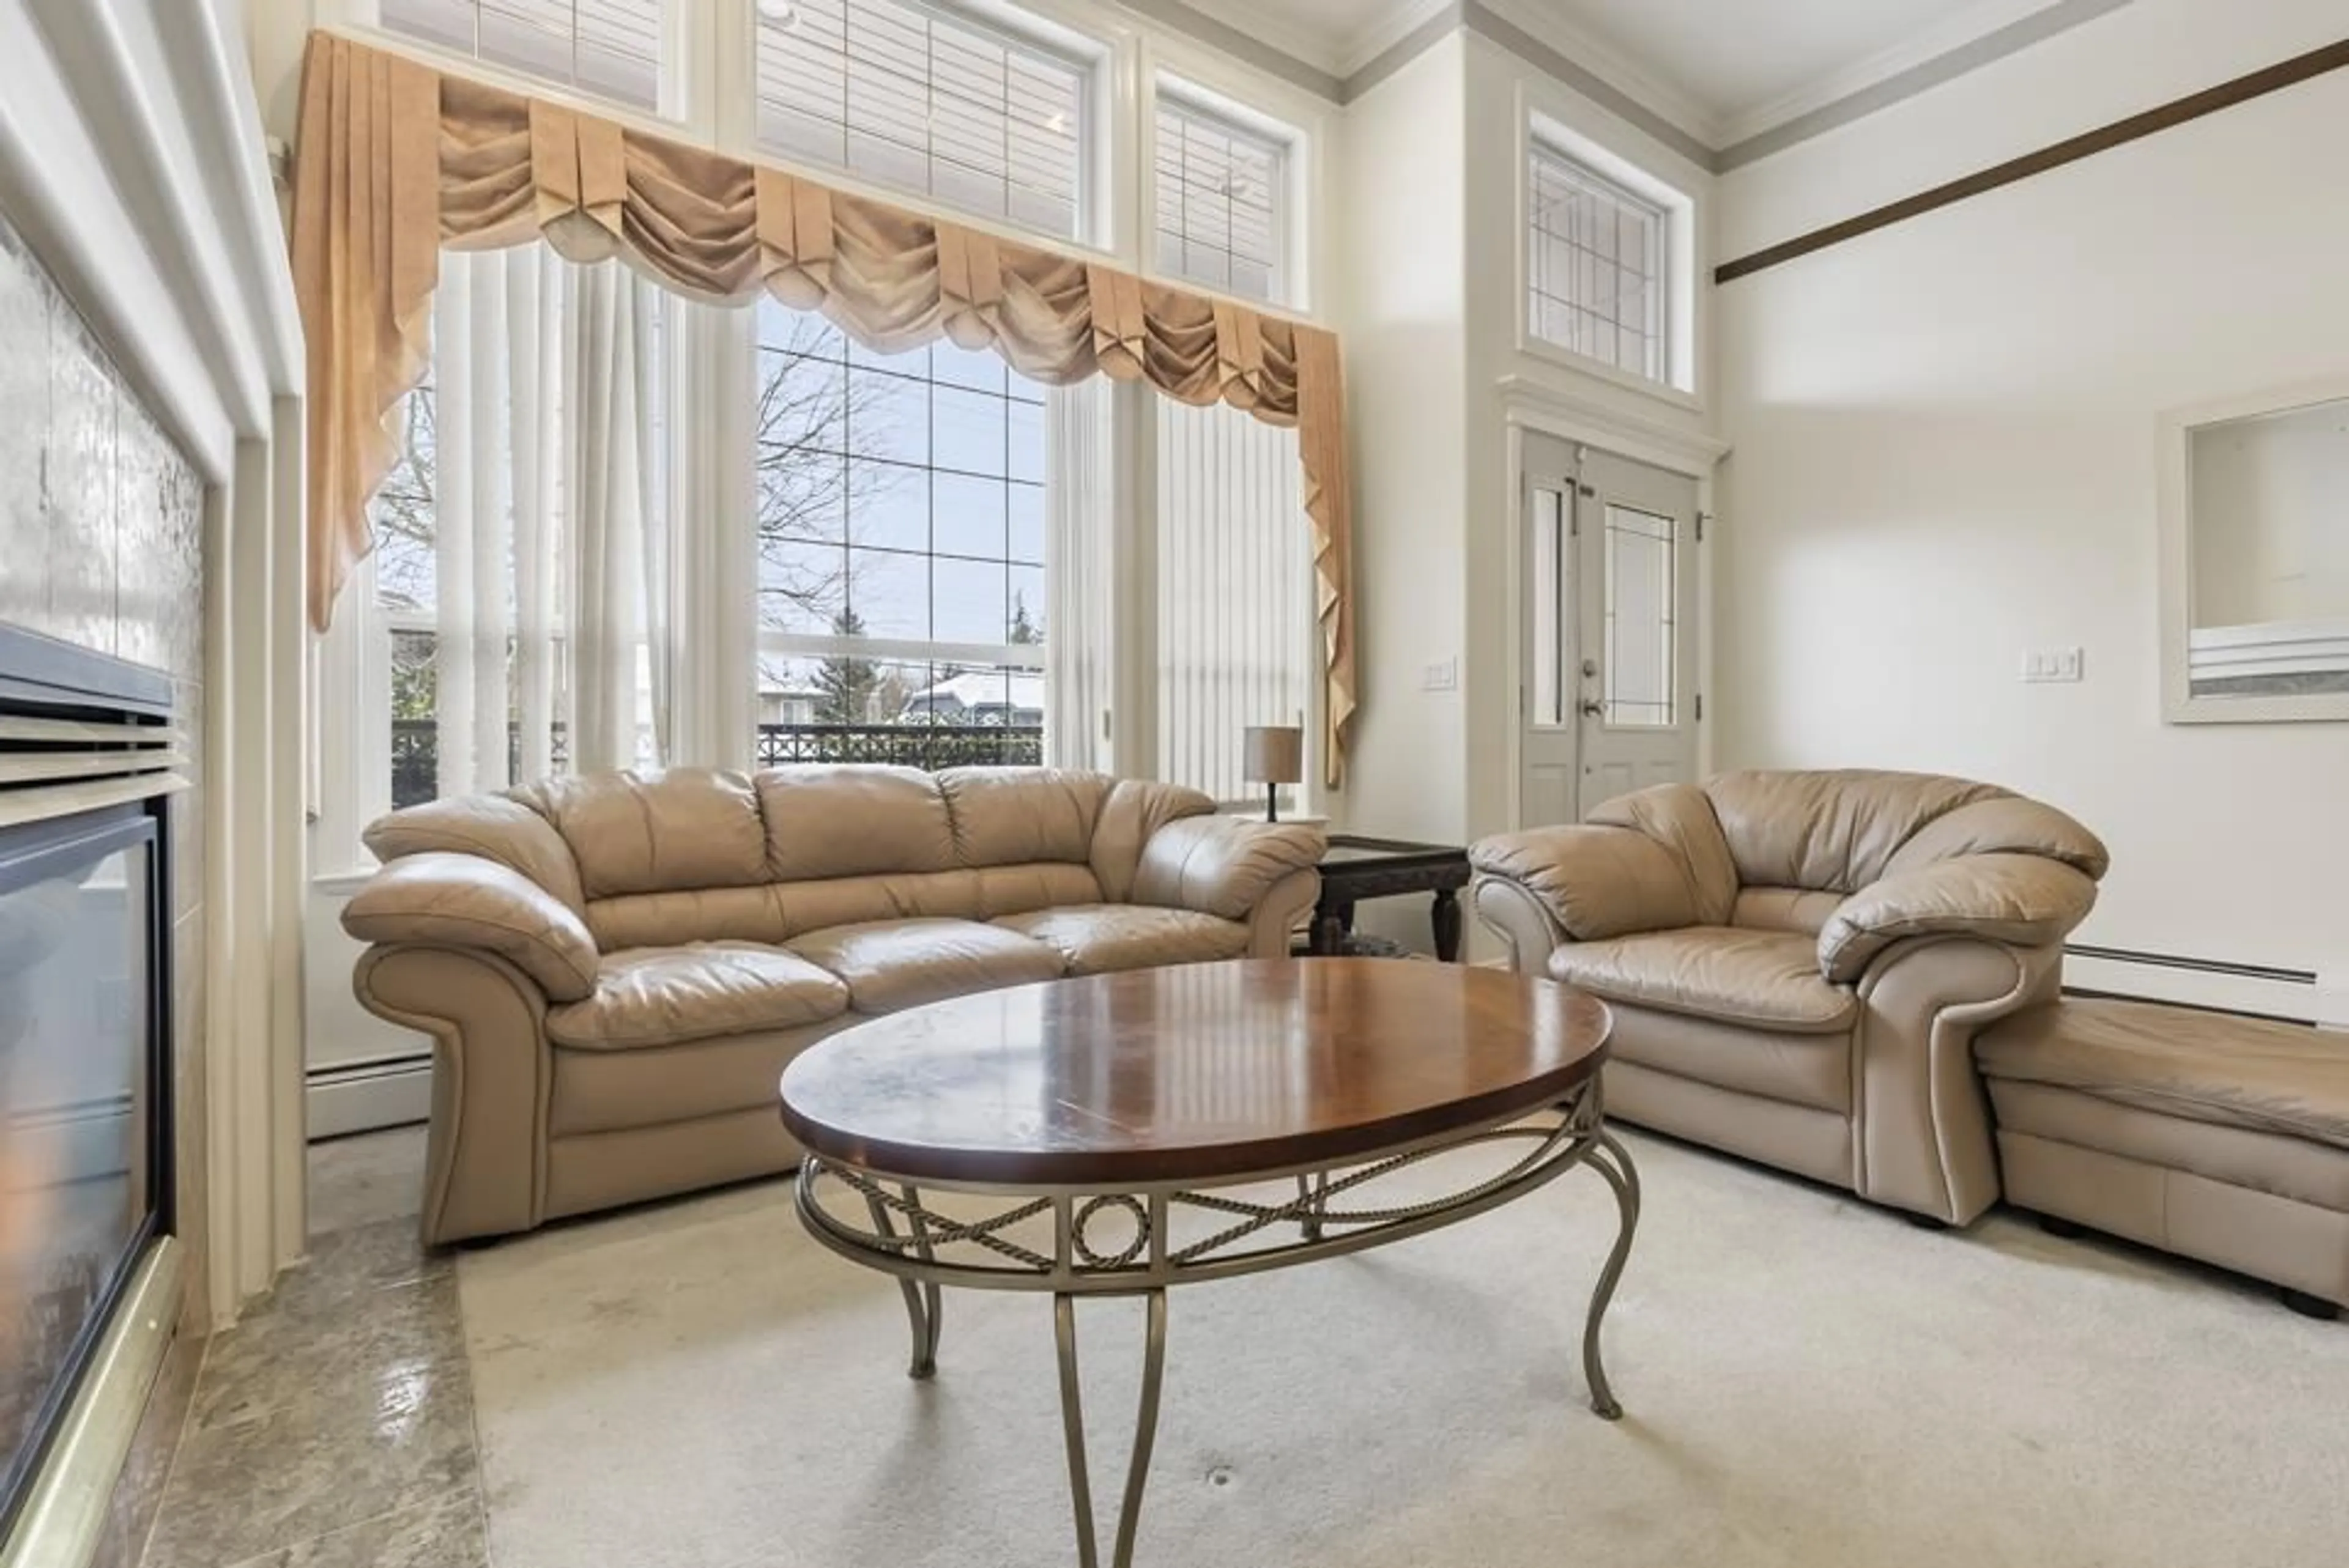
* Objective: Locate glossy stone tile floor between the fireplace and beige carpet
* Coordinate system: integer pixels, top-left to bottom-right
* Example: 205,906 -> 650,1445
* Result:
143,1126 -> 489,1568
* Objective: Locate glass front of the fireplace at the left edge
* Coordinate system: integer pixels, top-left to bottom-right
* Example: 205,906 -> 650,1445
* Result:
0,805 -> 167,1528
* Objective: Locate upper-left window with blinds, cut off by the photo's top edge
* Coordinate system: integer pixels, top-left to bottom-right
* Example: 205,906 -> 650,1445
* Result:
378,0 -> 669,113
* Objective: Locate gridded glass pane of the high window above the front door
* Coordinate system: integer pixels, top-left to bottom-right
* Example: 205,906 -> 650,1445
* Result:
1527,146 -> 1670,380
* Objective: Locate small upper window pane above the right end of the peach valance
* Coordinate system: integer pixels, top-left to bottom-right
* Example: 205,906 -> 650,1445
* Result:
1158,89 -> 1287,300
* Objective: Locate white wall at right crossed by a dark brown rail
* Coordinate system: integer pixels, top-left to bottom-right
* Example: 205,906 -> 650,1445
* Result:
1717,0 -> 2349,1000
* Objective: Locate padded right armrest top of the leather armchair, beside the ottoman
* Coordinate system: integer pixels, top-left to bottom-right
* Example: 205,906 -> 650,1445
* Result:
1818,854 -> 2095,986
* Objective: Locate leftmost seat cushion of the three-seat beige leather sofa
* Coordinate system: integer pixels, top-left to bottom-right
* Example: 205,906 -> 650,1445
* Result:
547,941 -> 848,1052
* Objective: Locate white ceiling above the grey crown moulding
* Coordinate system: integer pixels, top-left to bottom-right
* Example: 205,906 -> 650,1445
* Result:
1191,0 -> 2060,146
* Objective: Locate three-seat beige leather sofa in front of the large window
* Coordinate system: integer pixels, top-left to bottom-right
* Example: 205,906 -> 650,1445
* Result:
343,767 -> 1325,1241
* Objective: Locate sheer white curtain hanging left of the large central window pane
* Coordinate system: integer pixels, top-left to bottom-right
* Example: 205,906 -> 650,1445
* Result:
432,246 -> 677,796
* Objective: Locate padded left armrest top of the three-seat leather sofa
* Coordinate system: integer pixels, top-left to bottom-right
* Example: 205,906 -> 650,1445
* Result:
343,852 -> 596,1002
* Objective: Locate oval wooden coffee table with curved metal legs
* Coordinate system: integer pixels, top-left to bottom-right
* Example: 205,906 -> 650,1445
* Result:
782,958 -> 1639,1568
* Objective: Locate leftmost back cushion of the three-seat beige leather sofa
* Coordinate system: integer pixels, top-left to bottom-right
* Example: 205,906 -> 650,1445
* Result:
514,767 -> 766,899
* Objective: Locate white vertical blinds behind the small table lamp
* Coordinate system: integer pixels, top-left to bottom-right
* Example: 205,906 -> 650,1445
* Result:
1151,397 -> 1313,805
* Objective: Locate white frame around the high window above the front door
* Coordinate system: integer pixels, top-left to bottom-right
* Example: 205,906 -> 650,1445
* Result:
1513,108 -> 1703,411
